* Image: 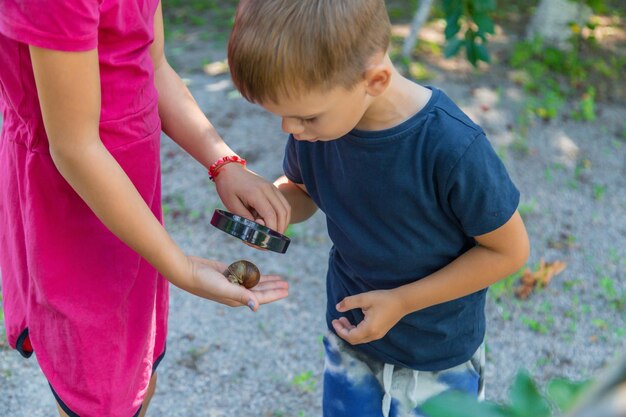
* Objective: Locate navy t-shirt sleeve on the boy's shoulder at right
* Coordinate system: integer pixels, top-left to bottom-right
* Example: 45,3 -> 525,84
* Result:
446,134 -> 520,236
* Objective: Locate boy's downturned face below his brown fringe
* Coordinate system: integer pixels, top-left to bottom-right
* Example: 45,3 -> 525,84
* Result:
261,83 -> 370,142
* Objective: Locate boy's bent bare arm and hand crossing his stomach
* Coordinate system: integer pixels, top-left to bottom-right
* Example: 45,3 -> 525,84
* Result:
333,211 -> 530,344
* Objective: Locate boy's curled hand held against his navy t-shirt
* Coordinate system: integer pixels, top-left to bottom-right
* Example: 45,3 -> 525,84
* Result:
332,290 -> 405,345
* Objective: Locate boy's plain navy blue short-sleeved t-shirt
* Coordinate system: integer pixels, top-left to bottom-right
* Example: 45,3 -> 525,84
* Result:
283,88 -> 519,371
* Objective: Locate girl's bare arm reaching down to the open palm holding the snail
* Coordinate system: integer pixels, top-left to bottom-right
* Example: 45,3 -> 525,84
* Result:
30,46 -> 287,308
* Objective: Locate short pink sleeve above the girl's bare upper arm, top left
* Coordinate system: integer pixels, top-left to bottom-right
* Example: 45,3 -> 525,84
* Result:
0,0 -> 101,51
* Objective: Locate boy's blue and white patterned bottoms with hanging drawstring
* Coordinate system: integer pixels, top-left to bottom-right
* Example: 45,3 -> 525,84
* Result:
323,333 -> 485,417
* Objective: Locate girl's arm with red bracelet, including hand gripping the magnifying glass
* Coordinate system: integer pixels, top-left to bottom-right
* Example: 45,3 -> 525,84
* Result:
150,4 -> 290,232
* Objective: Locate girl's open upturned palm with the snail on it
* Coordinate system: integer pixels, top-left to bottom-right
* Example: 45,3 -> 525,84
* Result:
183,256 -> 289,311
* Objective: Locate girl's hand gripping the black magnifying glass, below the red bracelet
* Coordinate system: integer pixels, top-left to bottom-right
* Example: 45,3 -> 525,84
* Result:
215,164 -> 291,233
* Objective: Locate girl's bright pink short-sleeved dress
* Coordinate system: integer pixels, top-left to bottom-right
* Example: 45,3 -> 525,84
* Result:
0,0 -> 168,417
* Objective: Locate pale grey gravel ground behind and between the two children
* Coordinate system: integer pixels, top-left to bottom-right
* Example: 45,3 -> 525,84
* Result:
0,40 -> 626,417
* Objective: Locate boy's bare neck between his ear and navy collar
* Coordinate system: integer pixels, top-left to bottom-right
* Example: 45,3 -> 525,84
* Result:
356,65 -> 432,131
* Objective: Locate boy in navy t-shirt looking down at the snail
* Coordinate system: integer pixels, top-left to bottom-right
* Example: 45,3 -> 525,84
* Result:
228,0 -> 529,417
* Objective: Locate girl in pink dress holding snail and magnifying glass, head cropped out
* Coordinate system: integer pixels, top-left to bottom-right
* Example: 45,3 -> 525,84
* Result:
0,0 -> 290,417
